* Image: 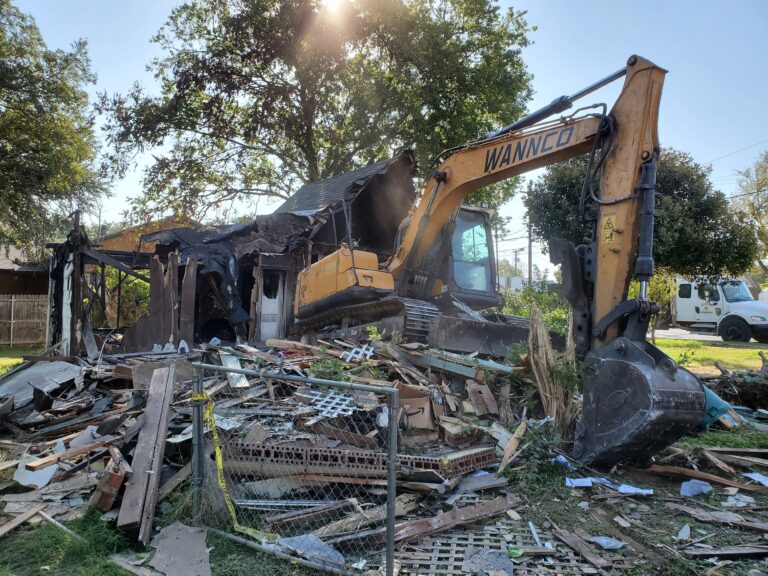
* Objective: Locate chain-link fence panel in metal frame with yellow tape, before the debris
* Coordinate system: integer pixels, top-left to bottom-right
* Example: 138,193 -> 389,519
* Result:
192,363 -> 399,575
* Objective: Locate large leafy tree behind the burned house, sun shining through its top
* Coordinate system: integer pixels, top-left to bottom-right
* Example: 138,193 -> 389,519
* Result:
99,0 -> 531,217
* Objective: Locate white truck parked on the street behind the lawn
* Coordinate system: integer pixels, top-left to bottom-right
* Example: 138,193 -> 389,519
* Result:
672,278 -> 768,344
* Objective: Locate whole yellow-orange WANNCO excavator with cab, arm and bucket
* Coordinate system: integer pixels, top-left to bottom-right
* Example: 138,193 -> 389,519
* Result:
294,56 -> 705,465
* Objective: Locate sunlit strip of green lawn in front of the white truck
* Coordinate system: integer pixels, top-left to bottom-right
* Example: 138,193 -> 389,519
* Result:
656,338 -> 768,372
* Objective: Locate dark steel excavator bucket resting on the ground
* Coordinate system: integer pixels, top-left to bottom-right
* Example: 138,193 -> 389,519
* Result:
573,337 -> 705,467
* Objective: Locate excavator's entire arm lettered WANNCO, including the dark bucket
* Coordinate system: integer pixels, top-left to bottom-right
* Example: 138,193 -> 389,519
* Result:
387,56 -> 705,465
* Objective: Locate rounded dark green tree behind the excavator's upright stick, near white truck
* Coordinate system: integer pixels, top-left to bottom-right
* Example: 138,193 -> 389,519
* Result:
525,149 -> 757,276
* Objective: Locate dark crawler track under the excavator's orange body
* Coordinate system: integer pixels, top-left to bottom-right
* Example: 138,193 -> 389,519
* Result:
293,296 -> 440,343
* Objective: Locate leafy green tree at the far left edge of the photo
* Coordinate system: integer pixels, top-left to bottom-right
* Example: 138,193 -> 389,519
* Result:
0,0 -> 102,246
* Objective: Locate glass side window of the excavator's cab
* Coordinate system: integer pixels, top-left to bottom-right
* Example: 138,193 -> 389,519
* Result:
452,211 -> 491,292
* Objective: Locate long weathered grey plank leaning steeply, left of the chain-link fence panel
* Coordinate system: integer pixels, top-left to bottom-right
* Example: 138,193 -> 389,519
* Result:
117,365 -> 175,545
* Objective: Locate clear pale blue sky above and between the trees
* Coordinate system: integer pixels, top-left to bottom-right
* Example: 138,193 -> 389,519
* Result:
19,0 -> 768,268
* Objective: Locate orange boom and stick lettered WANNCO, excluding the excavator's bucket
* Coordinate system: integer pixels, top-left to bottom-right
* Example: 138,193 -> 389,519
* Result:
387,56 -> 666,352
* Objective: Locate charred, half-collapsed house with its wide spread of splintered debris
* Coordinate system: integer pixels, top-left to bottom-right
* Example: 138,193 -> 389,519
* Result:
0,153 -> 768,576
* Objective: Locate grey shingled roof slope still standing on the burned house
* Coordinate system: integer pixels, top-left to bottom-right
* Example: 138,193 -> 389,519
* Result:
275,150 -> 416,214
